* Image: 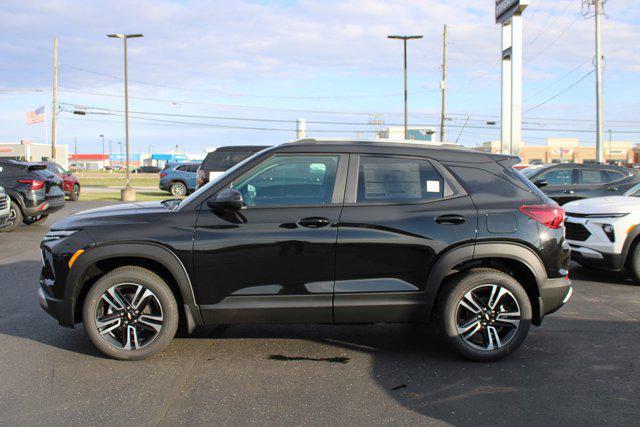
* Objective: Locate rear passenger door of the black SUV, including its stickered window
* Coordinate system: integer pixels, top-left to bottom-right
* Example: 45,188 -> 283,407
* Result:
333,155 -> 477,323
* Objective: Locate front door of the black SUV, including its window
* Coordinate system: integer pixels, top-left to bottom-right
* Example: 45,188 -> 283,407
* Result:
194,153 -> 348,323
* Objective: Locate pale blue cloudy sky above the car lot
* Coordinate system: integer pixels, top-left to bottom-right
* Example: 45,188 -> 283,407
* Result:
0,0 -> 640,154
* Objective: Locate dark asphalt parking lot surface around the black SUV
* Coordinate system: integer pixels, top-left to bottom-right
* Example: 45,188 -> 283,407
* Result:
0,202 -> 640,425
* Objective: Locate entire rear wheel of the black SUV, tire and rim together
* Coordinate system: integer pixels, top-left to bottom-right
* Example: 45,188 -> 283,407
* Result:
437,268 -> 531,362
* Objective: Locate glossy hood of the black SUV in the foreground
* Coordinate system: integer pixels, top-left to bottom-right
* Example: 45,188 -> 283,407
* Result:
51,201 -> 171,230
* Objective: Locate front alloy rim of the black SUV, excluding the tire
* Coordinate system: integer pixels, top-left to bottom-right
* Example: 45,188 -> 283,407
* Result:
95,283 -> 163,350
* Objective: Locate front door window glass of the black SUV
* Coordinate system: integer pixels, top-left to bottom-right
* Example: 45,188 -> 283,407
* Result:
231,155 -> 340,206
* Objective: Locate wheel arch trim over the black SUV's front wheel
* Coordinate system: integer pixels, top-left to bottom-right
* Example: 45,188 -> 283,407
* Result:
65,242 -> 202,332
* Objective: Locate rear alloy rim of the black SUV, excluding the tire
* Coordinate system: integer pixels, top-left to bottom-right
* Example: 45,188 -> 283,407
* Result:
456,284 -> 521,351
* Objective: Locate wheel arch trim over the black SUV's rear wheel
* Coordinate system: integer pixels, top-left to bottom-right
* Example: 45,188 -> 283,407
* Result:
426,242 -> 547,325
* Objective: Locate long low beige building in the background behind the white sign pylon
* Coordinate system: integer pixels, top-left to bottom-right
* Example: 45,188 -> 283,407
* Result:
473,138 -> 640,165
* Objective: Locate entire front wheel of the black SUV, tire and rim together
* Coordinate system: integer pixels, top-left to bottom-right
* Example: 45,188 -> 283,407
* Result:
82,266 -> 178,360
